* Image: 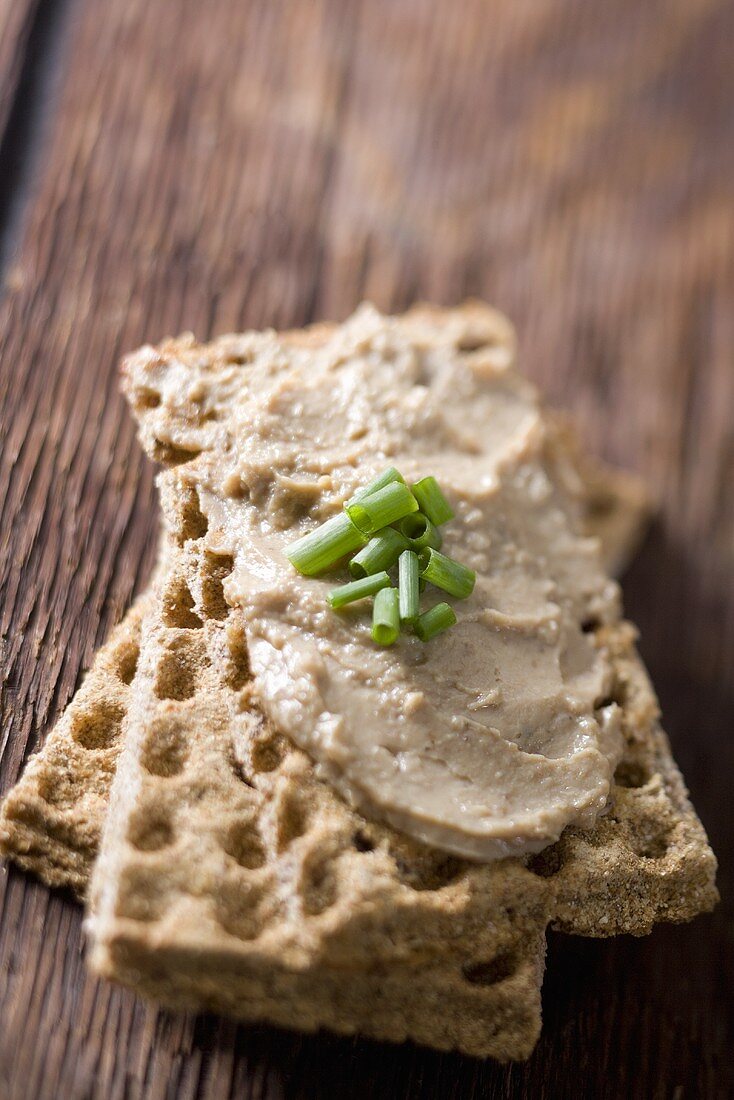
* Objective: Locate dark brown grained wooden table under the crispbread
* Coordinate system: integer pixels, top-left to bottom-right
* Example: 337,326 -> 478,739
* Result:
0,0 -> 734,1100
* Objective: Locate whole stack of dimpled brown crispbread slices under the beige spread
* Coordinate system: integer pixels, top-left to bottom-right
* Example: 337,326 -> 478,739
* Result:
0,304 -> 716,1059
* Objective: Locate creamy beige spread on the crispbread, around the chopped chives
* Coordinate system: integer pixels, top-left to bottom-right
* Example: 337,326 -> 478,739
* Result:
164,307 -> 622,860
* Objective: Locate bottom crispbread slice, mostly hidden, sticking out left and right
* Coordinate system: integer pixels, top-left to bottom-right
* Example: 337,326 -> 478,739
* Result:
0,304 -> 649,902
